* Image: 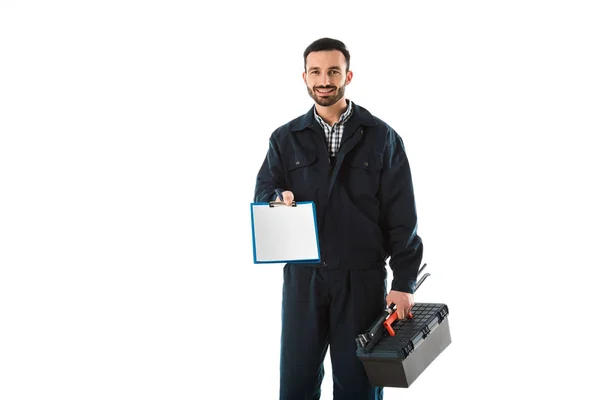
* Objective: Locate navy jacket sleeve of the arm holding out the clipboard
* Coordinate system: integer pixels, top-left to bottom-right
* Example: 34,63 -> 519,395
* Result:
254,134 -> 285,202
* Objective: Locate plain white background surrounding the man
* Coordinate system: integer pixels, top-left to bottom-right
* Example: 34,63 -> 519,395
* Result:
0,0 -> 600,400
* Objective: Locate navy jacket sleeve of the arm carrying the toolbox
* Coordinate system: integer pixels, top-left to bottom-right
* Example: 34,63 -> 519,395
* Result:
380,128 -> 423,293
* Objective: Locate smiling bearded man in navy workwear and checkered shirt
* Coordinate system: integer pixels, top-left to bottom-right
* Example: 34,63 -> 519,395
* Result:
254,38 -> 423,400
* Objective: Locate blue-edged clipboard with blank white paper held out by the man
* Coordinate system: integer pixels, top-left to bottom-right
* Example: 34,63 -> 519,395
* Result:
250,201 -> 321,264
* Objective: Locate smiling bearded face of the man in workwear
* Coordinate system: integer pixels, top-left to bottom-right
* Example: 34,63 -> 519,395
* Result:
302,50 -> 352,107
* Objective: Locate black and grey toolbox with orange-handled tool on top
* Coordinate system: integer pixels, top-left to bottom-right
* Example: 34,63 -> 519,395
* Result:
356,265 -> 452,388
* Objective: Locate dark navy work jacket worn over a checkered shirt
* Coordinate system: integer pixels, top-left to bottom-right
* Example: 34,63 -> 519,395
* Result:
254,104 -> 423,293
